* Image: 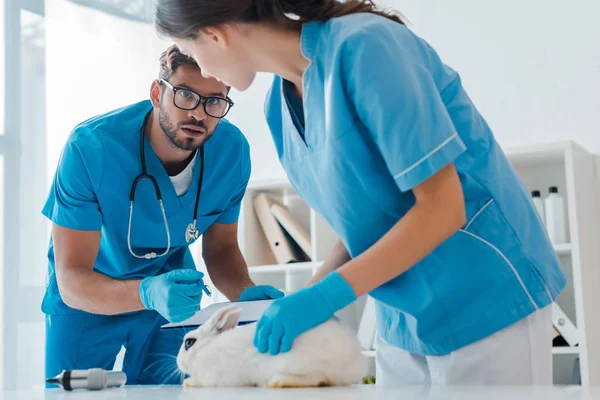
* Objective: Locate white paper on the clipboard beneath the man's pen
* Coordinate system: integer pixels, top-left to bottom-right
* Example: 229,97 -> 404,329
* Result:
161,299 -> 274,329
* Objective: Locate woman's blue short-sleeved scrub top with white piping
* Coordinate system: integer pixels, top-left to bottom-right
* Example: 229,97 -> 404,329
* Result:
265,14 -> 566,355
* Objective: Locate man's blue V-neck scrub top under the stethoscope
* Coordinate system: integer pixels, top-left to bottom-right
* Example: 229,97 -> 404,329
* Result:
42,101 -> 250,314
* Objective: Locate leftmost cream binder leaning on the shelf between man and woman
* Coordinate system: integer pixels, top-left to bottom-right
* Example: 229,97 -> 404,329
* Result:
253,193 -> 309,264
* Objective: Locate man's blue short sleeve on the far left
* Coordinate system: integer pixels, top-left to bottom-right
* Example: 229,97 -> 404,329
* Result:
42,134 -> 102,231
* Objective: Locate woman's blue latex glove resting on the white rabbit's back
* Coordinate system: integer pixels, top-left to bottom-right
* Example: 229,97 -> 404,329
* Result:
254,271 -> 356,355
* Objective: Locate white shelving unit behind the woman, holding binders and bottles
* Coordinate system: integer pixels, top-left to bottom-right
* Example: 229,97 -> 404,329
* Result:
239,142 -> 600,385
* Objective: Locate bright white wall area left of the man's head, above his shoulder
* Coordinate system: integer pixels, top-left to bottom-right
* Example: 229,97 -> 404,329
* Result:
46,0 -> 169,182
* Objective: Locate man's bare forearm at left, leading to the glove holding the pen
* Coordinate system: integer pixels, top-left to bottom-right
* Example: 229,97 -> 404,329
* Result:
57,268 -> 144,315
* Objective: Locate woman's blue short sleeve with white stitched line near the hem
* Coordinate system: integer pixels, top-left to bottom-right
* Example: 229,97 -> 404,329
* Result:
342,23 -> 466,191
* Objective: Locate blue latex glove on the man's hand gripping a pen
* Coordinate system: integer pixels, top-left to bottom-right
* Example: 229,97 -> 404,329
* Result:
140,269 -> 204,322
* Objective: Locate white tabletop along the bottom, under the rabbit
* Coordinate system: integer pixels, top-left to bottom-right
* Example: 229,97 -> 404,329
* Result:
0,385 -> 600,400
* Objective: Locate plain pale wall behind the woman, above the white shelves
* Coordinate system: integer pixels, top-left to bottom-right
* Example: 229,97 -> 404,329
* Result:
230,0 -> 600,180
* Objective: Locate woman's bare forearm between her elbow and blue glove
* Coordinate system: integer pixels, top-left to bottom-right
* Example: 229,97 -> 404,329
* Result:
338,195 -> 465,297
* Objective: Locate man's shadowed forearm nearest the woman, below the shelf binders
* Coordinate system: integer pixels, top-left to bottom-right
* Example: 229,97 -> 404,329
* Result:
204,244 -> 254,301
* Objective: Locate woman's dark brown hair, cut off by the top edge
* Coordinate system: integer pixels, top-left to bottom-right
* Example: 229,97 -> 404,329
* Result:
155,0 -> 404,39
